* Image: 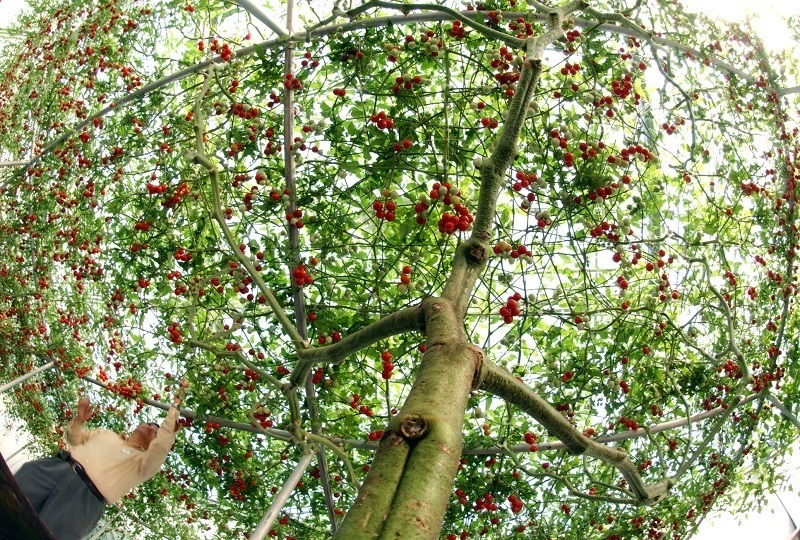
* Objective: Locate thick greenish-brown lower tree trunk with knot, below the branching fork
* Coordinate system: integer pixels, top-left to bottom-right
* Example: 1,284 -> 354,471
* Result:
334,298 -> 483,540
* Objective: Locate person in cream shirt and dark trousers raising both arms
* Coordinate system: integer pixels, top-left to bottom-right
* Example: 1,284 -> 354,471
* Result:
15,379 -> 188,540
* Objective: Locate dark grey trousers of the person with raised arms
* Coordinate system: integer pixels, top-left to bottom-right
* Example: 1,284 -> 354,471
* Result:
14,457 -> 105,540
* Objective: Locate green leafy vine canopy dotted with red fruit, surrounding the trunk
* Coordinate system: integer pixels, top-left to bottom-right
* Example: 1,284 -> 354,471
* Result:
0,0 -> 800,539
